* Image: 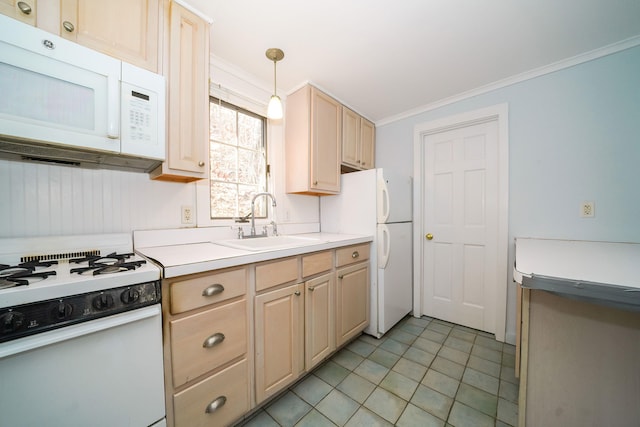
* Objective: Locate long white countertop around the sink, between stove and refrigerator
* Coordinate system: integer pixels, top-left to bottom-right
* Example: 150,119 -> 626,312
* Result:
136,233 -> 373,278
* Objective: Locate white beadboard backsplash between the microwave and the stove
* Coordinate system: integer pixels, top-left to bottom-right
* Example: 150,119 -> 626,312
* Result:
0,160 -> 196,237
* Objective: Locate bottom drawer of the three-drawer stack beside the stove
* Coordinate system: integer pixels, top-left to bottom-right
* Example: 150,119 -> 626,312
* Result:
173,359 -> 249,427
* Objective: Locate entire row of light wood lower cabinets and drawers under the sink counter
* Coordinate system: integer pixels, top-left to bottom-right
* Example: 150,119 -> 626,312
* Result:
162,243 -> 369,427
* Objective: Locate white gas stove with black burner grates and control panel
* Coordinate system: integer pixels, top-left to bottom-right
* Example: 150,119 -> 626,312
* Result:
0,234 -> 165,427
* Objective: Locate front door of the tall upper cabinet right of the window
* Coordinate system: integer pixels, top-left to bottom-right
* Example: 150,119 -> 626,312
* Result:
310,87 -> 342,193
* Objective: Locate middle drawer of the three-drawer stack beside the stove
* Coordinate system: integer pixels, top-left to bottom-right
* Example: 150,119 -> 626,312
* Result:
169,300 -> 247,387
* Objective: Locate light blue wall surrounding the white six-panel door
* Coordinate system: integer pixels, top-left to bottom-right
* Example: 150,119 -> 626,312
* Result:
376,46 -> 640,342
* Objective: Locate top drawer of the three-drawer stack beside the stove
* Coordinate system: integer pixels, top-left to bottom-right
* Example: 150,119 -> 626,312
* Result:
170,268 -> 247,314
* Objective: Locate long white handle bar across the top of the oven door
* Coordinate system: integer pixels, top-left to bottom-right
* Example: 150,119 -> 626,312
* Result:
0,304 -> 161,359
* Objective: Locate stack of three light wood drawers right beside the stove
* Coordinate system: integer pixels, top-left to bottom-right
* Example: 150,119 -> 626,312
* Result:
162,266 -> 253,427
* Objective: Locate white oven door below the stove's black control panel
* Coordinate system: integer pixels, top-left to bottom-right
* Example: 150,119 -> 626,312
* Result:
0,304 -> 165,427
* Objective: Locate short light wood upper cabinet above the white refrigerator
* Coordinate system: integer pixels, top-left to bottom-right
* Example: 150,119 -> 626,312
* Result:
342,106 -> 375,170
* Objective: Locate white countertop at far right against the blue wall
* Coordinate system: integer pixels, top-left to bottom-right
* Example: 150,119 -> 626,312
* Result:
513,238 -> 640,288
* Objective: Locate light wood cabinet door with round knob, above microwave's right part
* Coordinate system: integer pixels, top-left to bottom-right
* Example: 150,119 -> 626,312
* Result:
60,0 -> 160,72
